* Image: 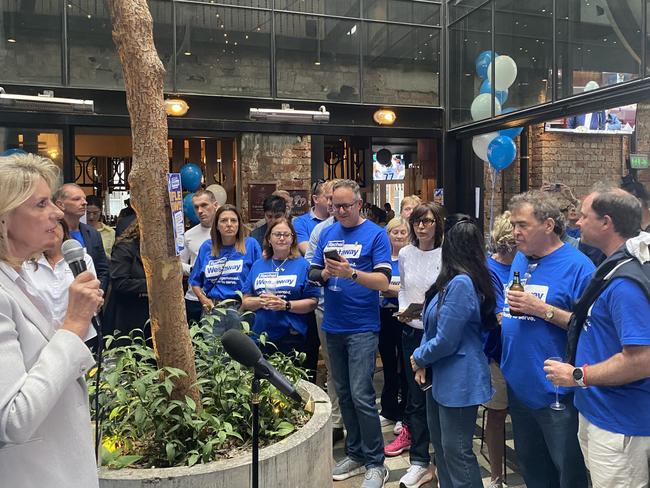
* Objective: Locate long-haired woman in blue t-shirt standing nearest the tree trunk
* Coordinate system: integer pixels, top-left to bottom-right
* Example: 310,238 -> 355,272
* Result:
189,204 -> 262,335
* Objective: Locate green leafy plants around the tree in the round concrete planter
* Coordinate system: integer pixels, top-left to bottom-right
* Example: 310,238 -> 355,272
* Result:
89,318 -> 308,468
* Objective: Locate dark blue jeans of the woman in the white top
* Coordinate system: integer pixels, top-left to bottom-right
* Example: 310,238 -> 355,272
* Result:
402,325 -> 431,466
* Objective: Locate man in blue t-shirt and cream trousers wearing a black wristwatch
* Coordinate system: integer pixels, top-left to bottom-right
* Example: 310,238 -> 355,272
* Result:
544,186 -> 650,488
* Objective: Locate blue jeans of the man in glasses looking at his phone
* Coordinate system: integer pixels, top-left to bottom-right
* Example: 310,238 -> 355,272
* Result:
325,332 -> 384,468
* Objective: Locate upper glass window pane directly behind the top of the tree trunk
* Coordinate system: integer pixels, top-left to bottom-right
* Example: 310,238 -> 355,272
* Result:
66,0 -> 173,89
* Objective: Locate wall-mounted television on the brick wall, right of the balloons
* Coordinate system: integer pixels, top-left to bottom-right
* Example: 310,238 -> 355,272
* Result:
544,104 -> 636,135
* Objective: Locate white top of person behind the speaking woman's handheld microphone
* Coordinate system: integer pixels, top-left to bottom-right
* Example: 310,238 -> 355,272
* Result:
23,254 -> 97,341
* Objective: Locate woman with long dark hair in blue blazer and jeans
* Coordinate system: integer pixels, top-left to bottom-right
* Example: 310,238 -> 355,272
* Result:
411,214 -> 497,488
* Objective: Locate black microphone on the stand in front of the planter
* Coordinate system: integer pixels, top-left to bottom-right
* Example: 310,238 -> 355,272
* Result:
221,329 -> 304,403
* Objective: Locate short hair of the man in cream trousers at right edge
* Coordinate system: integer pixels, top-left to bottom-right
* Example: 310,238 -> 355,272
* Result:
591,182 -> 641,239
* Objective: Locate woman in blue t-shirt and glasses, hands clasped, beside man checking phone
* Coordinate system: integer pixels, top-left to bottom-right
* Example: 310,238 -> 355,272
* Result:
242,217 -> 320,354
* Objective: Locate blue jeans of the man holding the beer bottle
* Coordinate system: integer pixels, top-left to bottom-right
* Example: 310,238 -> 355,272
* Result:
508,388 -> 587,488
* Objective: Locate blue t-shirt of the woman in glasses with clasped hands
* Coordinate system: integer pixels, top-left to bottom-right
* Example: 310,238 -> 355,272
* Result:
243,257 -> 320,341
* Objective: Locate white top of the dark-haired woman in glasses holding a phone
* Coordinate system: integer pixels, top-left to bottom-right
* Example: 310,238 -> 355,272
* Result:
398,244 -> 442,329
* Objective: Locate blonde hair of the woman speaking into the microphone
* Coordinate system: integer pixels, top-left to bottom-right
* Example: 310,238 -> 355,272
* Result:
0,153 -> 60,265
